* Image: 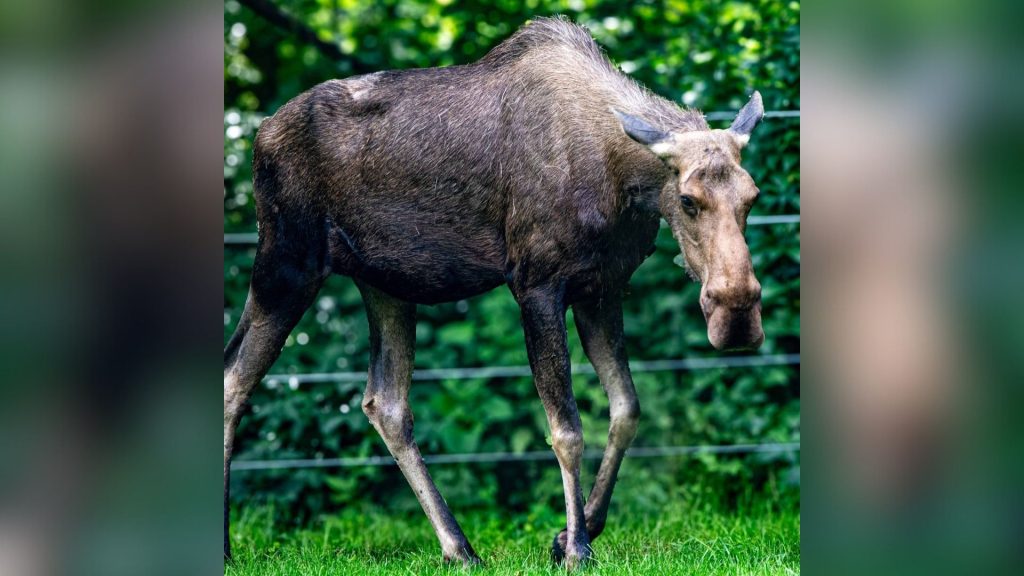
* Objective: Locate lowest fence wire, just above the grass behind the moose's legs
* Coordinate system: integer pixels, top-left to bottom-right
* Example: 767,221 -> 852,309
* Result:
231,442 -> 800,471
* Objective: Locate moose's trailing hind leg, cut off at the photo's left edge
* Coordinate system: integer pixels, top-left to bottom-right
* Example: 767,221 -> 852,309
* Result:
224,241 -> 324,558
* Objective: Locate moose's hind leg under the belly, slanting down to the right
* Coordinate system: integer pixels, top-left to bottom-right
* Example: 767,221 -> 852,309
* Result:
358,284 -> 480,566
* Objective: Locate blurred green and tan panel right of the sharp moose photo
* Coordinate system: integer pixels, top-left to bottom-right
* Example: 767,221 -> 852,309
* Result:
801,0 -> 1024,575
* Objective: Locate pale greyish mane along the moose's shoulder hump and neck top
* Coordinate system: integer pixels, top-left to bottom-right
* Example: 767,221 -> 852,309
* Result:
478,17 -> 709,132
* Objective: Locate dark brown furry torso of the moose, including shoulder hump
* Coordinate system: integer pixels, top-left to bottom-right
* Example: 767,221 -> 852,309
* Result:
254,19 -> 708,303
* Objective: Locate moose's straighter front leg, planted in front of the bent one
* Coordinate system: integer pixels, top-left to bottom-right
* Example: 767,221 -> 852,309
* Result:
516,290 -> 592,568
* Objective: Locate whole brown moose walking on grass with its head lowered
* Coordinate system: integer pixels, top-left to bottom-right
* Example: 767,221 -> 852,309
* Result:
224,18 -> 764,567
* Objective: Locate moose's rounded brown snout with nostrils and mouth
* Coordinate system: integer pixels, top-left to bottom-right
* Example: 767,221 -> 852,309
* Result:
700,276 -> 765,349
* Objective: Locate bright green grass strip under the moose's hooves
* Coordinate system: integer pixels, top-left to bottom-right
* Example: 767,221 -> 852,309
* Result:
225,498 -> 800,576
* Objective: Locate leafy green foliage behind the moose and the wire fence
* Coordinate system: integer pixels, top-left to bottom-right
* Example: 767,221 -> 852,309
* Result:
224,0 -> 800,521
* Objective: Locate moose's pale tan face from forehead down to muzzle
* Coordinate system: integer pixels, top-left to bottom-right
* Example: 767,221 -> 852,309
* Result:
651,130 -> 764,349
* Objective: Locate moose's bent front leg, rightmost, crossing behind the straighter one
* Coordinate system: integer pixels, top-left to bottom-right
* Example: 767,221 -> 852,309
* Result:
552,295 -> 640,558
